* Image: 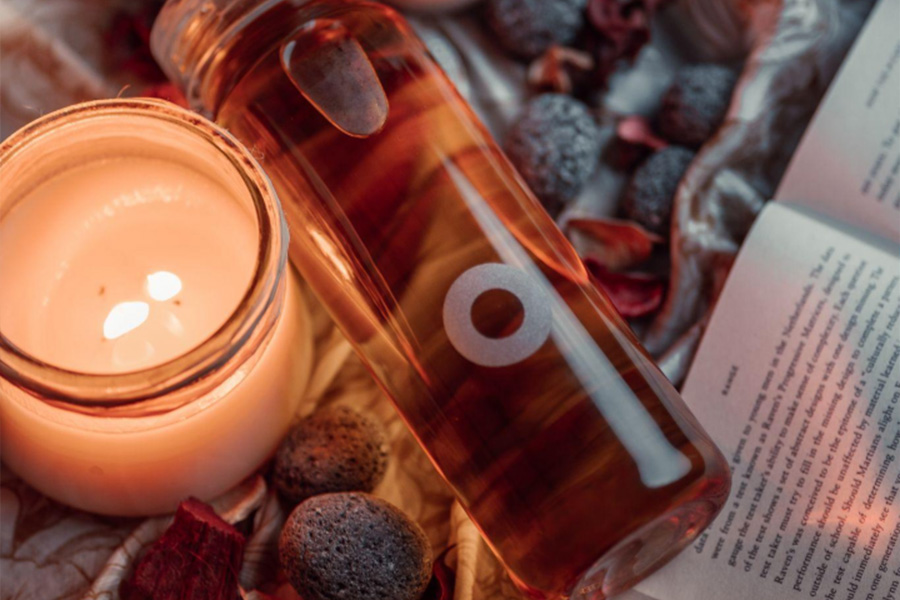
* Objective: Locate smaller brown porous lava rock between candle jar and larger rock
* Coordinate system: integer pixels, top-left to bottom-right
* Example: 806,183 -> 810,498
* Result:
272,406 -> 388,504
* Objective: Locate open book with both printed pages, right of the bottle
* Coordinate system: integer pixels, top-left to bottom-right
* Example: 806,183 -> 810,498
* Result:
625,0 -> 900,600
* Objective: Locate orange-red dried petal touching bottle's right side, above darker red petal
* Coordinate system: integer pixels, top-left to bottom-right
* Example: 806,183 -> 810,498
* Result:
566,219 -> 663,271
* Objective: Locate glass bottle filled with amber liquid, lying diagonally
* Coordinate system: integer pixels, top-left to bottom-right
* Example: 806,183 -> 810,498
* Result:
153,2 -> 729,600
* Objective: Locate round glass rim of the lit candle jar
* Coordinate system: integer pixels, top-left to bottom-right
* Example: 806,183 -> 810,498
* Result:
0,98 -> 288,412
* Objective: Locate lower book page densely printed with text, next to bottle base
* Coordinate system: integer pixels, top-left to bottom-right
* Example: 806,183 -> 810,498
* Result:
638,203 -> 900,600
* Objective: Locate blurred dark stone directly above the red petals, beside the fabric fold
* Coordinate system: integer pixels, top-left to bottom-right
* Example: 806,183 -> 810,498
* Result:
622,146 -> 695,236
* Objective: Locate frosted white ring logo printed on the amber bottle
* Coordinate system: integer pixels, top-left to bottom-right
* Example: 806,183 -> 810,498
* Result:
443,263 -> 553,367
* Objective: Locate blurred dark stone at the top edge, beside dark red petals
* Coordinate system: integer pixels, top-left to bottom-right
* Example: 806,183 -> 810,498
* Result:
487,0 -> 588,59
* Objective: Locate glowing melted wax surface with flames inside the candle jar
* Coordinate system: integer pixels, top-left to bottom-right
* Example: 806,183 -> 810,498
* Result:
0,158 -> 259,373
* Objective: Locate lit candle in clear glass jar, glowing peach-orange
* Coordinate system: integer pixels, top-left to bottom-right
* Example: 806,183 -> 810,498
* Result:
0,100 -> 312,515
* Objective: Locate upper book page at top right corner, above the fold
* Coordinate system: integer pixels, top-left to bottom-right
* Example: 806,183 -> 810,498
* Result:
775,0 -> 900,243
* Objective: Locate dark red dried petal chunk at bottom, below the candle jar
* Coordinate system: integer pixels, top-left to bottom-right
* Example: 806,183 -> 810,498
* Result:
119,498 -> 245,600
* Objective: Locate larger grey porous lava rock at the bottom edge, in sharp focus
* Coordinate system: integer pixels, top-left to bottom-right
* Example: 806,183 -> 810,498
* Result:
278,492 -> 432,600
